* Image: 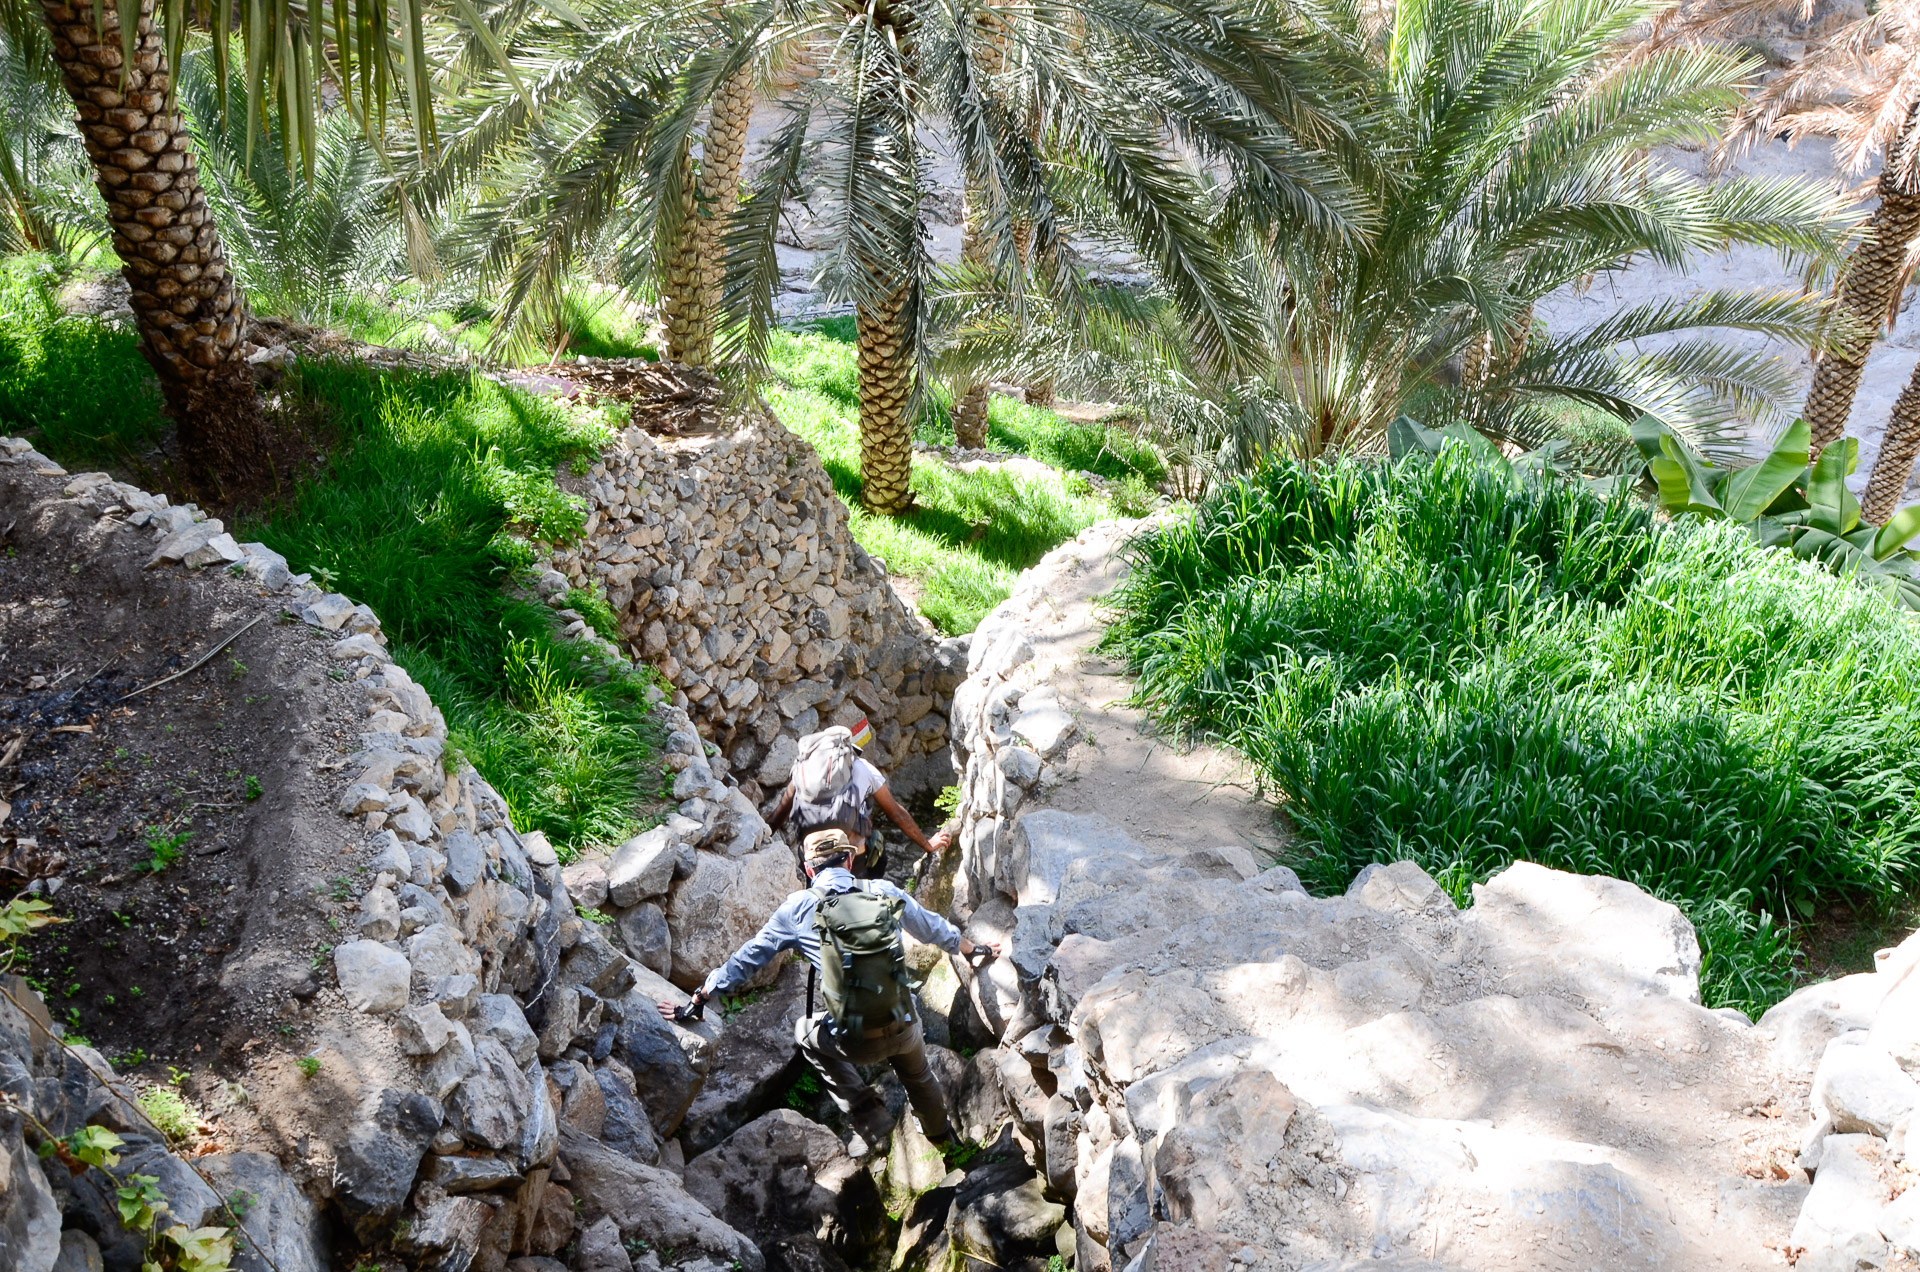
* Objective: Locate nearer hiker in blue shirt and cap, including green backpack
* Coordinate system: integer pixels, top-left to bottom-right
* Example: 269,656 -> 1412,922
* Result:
660,828 -> 1000,1157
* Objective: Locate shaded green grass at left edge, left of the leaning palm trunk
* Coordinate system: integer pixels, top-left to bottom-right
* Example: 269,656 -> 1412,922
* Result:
0,256 -> 167,469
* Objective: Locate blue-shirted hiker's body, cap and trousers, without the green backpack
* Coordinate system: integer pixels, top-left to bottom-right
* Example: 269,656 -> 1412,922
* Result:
660,830 -> 1000,1157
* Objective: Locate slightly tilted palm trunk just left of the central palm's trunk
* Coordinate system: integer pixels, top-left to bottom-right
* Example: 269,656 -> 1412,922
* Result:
666,67 -> 753,367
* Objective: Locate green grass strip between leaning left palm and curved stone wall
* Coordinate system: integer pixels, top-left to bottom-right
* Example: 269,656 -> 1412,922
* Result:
246,361 -> 660,851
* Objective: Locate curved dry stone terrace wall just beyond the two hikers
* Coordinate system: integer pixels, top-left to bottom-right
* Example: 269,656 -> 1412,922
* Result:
541,407 -> 966,799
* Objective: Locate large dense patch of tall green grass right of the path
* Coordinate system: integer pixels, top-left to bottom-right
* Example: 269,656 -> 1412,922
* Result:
1110,450 -> 1920,1011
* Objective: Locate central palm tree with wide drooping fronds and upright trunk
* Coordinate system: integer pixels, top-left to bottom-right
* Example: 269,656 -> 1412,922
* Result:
428,0 -> 1363,513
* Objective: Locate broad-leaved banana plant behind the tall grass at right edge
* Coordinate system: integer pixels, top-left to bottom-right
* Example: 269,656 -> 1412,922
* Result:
1634,415 -> 1920,609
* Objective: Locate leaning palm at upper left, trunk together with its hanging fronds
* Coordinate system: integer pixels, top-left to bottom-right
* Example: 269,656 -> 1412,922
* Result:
0,0 -> 510,488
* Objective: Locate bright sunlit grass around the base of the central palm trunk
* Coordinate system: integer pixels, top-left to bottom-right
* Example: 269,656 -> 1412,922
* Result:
766,319 -> 1128,632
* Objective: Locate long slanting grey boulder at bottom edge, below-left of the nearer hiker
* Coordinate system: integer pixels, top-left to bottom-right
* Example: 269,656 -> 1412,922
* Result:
561,1130 -> 766,1272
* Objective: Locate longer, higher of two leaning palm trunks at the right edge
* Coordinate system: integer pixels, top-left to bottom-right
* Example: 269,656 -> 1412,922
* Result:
1801,122 -> 1920,455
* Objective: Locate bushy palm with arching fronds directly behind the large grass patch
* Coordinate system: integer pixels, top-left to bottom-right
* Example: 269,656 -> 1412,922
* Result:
952,0 -> 1845,465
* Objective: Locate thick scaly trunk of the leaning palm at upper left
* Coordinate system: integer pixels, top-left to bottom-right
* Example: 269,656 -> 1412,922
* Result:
42,0 -> 267,486
